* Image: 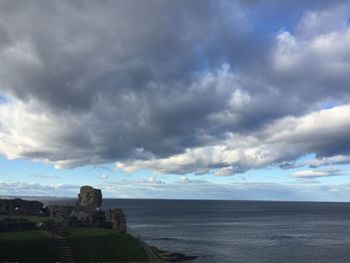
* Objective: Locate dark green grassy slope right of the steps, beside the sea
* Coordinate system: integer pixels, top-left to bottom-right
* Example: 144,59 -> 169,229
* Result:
69,228 -> 148,262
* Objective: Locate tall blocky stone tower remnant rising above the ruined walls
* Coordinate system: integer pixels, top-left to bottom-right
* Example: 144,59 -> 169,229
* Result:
77,185 -> 102,210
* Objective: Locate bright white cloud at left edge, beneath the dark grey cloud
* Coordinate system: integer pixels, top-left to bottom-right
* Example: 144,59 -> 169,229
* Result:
0,98 -> 110,168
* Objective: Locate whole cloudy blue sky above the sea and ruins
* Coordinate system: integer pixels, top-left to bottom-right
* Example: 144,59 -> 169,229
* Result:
0,0 -> 350,201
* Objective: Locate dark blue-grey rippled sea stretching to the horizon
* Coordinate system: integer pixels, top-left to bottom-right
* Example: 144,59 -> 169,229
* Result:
52,199 -> 350,263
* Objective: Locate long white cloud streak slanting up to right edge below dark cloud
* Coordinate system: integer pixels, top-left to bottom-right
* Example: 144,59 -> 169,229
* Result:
117,105 -> 350,175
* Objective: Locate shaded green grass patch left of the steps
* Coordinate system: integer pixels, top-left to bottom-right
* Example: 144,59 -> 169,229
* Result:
0,230 -> 58,262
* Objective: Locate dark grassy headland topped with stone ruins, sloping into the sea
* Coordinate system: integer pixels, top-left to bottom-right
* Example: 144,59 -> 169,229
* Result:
0,186 -> 196,262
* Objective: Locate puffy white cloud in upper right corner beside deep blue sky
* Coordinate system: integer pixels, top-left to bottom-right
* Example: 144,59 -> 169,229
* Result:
271,5 -> 350,87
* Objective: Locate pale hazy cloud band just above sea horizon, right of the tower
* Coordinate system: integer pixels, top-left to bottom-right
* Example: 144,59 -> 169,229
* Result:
99,178 -> 350,201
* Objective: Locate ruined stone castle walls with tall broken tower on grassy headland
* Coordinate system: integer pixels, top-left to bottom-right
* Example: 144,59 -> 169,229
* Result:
0,186 -> 127,233
